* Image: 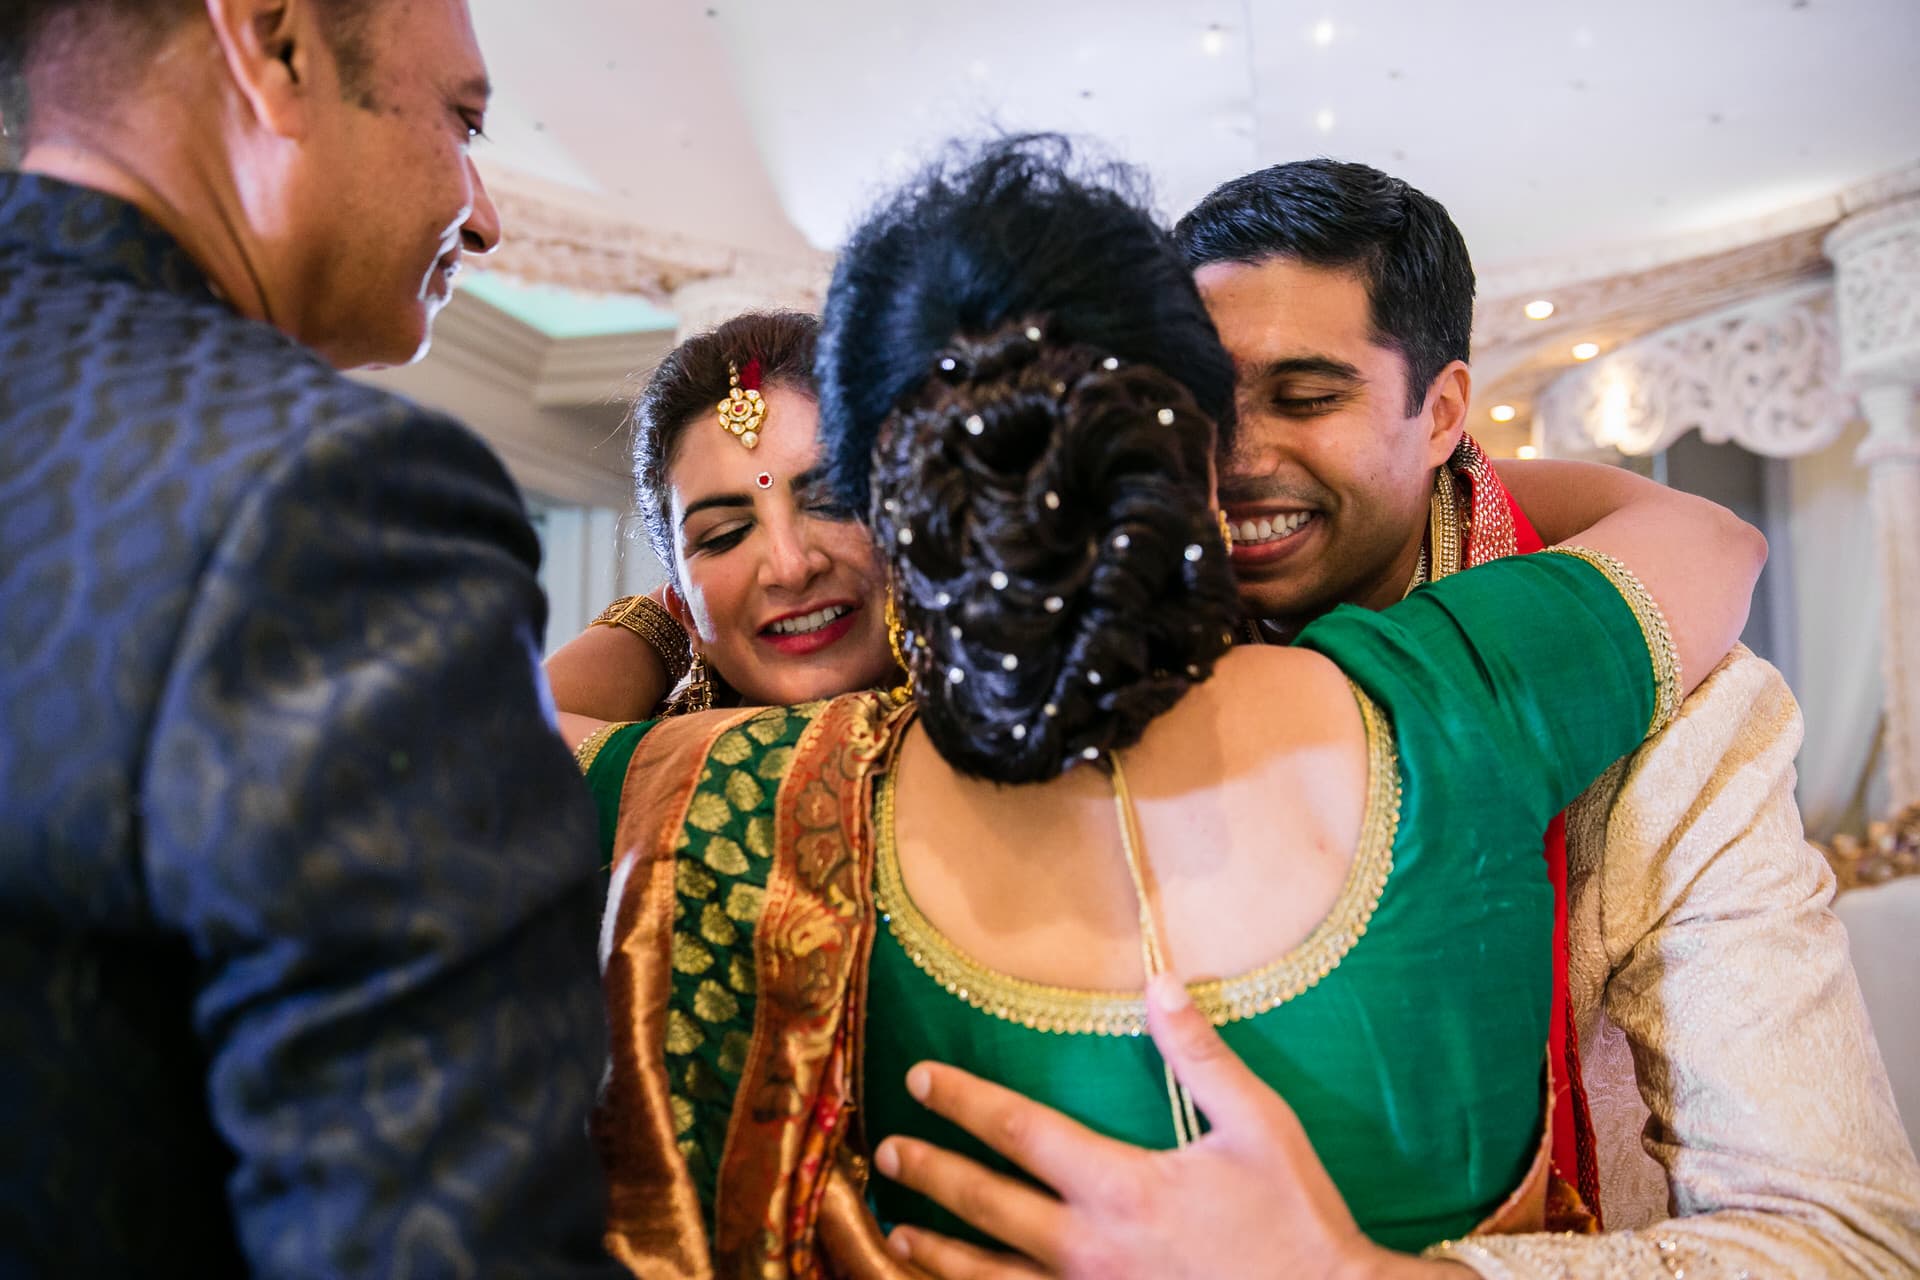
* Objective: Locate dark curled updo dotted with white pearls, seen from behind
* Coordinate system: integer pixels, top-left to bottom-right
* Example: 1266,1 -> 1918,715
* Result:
818,136 -> 1238,783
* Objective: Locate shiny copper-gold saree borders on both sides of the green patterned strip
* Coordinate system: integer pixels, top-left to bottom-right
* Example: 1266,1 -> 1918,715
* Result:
593,695 -> 908,1278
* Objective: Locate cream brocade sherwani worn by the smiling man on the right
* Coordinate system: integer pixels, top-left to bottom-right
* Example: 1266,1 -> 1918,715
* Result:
1430,649 -> 1920,1280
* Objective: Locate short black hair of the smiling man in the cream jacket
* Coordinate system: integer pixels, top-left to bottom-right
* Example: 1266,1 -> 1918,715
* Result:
1173,159 -> 1473,416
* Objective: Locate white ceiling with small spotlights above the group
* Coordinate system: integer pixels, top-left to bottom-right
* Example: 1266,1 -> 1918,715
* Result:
472,0 -> 1920,274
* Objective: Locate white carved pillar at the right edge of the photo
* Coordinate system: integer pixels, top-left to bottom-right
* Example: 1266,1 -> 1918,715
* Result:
1826,198 -> 1920,812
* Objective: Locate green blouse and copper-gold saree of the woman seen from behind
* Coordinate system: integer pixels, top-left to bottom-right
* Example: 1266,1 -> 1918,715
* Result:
584,555 -> 1676,1276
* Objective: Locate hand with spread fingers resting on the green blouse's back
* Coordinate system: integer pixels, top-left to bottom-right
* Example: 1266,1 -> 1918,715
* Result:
876,979 -> 1473,1280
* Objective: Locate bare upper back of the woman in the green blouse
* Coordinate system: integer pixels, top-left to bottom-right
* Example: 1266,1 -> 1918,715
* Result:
895,647 -> 1369,990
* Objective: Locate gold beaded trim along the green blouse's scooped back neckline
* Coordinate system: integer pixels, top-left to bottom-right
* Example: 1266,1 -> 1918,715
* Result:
874,681 -> 1400,1036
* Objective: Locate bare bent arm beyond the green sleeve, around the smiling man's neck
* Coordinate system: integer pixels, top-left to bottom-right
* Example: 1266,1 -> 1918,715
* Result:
1500,462 -> 1766,693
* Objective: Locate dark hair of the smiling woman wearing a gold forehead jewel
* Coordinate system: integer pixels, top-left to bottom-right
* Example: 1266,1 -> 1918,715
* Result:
634,311 -> 820,574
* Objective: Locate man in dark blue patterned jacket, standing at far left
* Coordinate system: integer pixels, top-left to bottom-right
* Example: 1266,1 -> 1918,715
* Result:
0,0 -> 611,1276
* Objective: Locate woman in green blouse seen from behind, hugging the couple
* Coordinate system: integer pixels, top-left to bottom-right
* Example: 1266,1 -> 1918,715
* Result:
595,140 -> 1764,1274
